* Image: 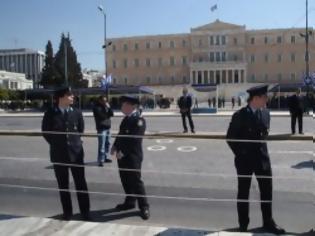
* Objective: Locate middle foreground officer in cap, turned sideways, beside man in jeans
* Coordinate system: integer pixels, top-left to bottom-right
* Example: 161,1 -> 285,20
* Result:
111,96 -> 150,220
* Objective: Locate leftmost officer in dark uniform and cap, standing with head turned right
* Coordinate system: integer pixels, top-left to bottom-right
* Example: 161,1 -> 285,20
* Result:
42,87 -> 91,220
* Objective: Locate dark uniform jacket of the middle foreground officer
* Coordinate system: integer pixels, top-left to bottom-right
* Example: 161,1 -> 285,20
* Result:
113,112 -> 146,163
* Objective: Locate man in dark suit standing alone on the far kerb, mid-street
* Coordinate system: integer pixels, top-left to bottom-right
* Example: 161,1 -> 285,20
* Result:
177,88 -> 195,133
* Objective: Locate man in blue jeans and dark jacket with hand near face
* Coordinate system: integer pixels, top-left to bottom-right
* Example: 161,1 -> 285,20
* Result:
93,95 -> 114,166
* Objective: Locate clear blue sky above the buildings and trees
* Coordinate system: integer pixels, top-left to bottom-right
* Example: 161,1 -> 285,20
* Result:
0,0 -> 315,70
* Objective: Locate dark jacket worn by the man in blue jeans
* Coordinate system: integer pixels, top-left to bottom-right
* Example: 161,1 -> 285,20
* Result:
93,103 -> 114,130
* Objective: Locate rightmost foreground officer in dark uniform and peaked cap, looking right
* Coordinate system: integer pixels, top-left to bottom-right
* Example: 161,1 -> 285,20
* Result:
227,85 -> 285,234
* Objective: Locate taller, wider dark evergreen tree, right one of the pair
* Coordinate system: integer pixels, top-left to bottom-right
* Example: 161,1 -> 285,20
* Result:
54,33 -> 87,88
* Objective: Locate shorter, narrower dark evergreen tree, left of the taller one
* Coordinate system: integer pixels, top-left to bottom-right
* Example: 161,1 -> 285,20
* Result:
41,40 -> 62,88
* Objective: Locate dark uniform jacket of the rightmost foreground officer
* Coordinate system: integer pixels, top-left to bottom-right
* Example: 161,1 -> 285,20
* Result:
226,106 -> 270,159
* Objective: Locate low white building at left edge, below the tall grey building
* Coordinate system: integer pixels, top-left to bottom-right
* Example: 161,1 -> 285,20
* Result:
0,70 -> 33,90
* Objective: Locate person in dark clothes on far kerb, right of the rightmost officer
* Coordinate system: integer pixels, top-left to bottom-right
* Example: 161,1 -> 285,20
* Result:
289,89 -> 304,134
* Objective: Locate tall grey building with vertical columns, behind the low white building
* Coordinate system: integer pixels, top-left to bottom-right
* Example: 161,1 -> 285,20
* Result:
0,48 -> 45,88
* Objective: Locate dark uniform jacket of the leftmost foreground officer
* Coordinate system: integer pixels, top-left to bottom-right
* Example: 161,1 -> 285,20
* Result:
42,106 -> 84,163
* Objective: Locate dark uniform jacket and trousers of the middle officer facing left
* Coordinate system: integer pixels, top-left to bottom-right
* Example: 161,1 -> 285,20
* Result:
113,112 -> 149,209
